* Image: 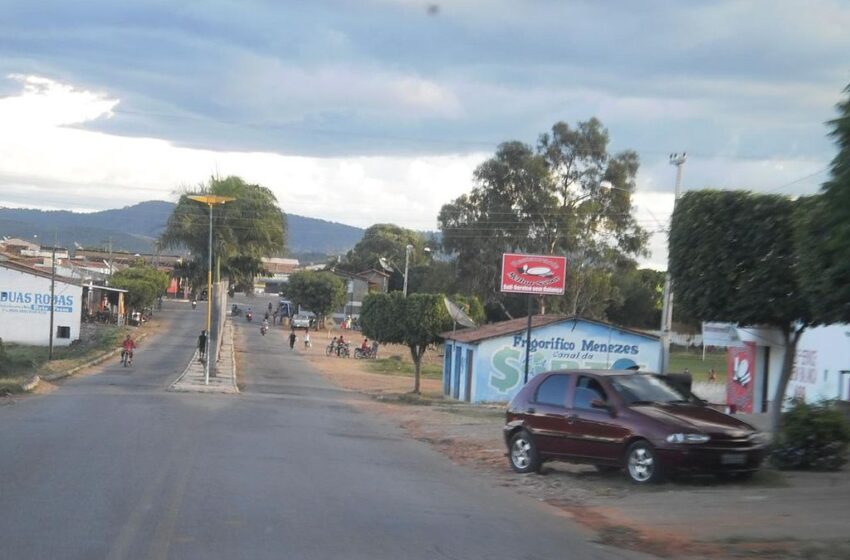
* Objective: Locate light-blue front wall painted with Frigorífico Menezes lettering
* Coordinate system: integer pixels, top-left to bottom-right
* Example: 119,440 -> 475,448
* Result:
473,321 -> 660,402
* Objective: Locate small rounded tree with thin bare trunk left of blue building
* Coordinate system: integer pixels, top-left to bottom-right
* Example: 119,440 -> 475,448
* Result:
360,292 -> 452,393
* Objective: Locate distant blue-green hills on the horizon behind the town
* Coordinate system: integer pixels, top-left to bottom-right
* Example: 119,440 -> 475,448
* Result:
0,200 -> 363,255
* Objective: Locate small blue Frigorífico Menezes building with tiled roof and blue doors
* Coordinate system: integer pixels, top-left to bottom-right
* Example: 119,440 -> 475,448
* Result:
443,315 -> 661,403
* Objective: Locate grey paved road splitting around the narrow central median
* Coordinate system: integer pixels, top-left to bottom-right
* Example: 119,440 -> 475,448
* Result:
0,304 -> 648,560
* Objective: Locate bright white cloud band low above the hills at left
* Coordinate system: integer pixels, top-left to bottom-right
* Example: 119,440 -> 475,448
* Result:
0,77 -> 476,229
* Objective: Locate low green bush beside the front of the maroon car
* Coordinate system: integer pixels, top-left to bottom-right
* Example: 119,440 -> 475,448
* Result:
771,399 -> 850,470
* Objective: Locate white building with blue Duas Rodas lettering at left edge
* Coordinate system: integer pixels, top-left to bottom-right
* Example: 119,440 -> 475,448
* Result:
0,261 -> 83,346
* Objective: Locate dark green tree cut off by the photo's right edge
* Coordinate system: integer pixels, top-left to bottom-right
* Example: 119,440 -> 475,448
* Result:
798,81 -> 850,323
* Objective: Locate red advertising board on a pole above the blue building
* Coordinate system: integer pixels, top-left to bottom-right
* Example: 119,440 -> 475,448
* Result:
502,253 -> 567,295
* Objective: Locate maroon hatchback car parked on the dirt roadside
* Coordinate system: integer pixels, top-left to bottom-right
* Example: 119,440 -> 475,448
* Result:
505,370 -> 767,483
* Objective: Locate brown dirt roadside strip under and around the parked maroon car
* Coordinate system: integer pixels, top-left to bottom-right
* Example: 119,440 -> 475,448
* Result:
300,336 -> 850,560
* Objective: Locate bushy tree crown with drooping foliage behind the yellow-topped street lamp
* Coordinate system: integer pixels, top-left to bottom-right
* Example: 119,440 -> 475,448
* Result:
159,177 -> 286,288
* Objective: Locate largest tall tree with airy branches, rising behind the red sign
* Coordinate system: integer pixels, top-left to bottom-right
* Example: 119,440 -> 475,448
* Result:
438,119 -> 647,314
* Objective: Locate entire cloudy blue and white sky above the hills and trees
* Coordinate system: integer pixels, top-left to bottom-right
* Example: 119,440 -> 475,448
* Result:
0,0 -> 850,267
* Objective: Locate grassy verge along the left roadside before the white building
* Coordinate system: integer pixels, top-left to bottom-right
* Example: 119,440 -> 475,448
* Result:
0,325 -> 128,385
